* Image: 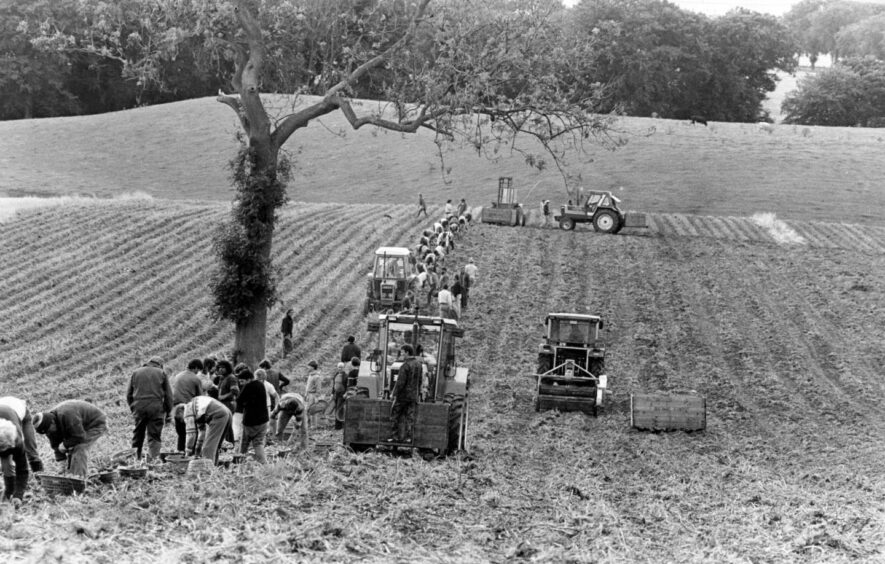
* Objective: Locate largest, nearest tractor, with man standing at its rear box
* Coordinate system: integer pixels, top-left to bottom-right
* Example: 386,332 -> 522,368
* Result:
344,314 -> 469,456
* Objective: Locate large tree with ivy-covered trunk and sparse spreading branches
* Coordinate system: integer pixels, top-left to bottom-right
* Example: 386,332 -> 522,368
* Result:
214,0 -> 617,363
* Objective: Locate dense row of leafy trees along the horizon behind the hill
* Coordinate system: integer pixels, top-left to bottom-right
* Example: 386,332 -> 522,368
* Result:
0,0 -> 885,126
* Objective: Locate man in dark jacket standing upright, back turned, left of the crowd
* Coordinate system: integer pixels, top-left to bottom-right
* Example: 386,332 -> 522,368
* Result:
126,356 -> 174,462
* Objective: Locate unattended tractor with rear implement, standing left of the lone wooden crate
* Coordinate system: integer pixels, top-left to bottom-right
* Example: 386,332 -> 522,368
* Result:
534,313 -> 610,417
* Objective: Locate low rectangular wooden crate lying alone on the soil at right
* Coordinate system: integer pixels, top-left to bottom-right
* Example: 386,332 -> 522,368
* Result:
630,393 -> 707,431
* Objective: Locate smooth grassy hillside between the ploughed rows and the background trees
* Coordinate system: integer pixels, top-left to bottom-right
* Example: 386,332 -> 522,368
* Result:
0,92 -> 885,225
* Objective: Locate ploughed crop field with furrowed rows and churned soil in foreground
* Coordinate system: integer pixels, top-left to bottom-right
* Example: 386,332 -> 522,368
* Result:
0,201 -> 885,563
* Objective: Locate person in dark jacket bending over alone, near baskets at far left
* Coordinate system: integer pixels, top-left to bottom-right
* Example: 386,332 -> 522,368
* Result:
34,400 -> 108,478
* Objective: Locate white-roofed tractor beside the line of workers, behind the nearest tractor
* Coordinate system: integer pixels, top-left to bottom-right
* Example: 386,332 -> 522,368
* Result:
363,247 -> 416,315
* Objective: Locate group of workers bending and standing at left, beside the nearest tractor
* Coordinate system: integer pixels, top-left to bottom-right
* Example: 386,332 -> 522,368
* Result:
0,336 -> 372,500
